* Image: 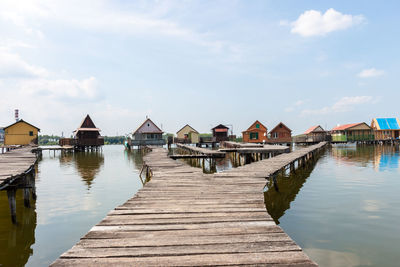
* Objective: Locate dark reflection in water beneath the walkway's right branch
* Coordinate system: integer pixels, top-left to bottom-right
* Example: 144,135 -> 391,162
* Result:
264,154 -> 318,224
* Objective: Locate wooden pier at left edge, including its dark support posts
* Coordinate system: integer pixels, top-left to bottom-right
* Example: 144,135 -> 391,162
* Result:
0,147 -> 37,223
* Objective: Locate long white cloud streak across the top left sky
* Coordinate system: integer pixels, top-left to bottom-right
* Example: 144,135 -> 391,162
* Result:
0,0 -> 231,53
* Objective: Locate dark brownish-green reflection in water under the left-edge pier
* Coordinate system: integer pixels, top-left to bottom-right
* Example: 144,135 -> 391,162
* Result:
0,189 -> 36,266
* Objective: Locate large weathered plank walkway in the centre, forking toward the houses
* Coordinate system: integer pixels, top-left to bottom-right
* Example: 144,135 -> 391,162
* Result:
52,143 -> 325,266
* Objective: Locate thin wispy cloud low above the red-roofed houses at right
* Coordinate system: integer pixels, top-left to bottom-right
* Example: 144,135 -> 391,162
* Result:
301,96 -> 373,116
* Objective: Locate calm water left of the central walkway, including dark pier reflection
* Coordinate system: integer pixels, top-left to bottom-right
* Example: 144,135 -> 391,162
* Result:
0,146 -> 142,266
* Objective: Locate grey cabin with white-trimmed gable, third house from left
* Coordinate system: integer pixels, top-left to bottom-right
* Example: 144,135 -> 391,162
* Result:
131,119 -> 165,146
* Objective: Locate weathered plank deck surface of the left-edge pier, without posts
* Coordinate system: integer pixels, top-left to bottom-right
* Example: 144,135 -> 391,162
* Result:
0,147 -> 37,190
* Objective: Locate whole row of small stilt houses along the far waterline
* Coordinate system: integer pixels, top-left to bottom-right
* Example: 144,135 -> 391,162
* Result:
0,115 -> 400,148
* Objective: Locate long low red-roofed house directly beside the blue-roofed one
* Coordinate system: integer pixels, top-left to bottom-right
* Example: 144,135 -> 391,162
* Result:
332,122 -> 375,142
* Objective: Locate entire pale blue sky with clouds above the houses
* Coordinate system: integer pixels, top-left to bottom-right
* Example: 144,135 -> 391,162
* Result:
0,0 -> 400,136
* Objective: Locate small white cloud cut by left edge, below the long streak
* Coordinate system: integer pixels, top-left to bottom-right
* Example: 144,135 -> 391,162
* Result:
0,47 -> 48,78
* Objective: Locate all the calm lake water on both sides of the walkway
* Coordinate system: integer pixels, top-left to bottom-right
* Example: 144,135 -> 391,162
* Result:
0,146 -> 400,266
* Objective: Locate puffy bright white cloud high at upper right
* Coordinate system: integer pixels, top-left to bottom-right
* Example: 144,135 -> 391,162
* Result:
291,8 -> 365,37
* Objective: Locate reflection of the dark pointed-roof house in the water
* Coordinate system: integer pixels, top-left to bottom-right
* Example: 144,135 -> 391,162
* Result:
59,151 -> 104,190
